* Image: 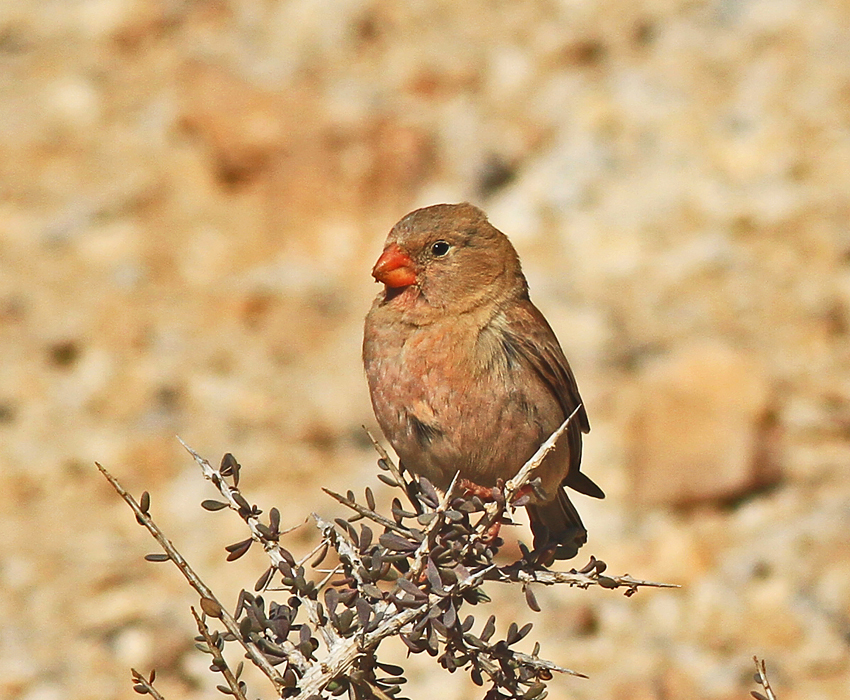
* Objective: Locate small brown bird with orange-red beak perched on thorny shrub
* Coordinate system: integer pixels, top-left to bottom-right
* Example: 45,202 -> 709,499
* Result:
363,202 -> 605,563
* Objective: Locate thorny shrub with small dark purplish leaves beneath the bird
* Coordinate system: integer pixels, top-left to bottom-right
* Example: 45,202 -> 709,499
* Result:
98,416 -> 684,700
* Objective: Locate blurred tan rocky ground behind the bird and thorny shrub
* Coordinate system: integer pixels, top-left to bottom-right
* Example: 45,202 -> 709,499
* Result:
0,0 -> 850,700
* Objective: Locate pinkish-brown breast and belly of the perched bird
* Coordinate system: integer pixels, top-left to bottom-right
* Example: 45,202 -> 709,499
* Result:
364,312 -> 559,487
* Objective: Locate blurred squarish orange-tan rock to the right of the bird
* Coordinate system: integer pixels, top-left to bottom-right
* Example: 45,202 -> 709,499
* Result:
626,343 -> 774,505
